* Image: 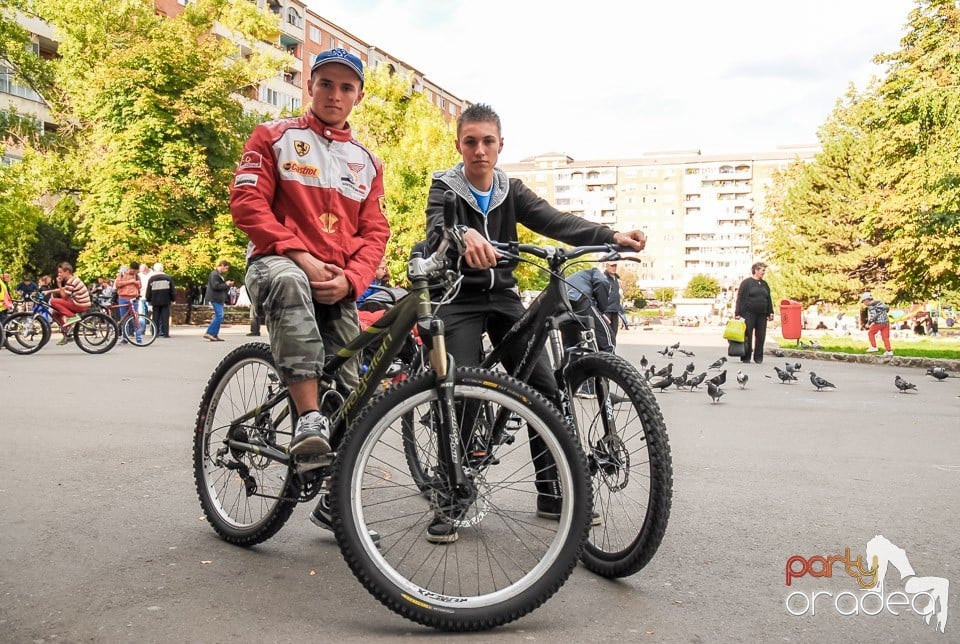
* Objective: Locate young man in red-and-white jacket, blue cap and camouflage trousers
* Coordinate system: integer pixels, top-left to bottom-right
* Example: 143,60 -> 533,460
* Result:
230,49 -> 390,457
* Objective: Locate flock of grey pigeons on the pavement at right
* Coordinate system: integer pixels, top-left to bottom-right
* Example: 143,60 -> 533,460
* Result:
640,342 -> 950,403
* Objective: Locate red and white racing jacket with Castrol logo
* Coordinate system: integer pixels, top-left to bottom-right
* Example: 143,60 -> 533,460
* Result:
230,111 -> 390,294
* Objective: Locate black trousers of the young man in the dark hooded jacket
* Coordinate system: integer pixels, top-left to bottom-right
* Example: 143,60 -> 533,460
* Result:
439,291 -> 560,497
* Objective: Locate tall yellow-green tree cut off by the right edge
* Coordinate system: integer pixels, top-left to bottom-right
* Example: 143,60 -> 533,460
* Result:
865,0 -> 960,299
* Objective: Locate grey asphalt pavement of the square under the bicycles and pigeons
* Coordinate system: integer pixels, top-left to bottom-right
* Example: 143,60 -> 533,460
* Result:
0,325 -> 960,642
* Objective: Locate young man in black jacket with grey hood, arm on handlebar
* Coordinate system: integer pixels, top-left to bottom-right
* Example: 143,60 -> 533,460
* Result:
427,104 -> 646,543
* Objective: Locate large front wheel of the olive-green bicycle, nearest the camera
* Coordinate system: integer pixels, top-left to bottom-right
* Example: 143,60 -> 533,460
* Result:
331,369 -> 590,631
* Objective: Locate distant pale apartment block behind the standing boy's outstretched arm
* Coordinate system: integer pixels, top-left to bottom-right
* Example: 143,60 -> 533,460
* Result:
501,146 -> 817,291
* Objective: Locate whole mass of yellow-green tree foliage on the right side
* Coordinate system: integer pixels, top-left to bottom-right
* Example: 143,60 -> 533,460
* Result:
766,0 -> 960,303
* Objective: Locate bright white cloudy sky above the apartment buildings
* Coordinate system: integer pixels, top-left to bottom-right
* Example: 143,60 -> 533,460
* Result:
308,0 -> 915,162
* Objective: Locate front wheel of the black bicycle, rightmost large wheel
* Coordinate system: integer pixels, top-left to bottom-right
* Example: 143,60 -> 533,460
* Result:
567,353 -> 673,577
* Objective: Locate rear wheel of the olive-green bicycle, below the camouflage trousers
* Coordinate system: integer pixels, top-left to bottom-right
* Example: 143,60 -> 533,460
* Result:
193,342 -> 300,546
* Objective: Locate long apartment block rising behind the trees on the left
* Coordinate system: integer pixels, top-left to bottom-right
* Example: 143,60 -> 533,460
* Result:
0,0 -> 470,163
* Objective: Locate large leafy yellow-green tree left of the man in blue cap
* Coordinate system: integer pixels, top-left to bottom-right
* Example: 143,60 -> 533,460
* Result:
21,0 -> 283,278
